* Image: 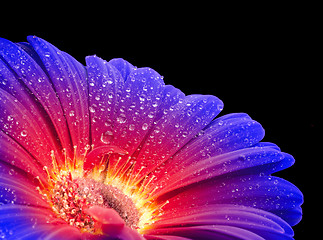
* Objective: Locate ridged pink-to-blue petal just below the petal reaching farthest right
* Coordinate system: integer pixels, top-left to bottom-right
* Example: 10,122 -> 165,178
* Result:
153,204 -> 293,239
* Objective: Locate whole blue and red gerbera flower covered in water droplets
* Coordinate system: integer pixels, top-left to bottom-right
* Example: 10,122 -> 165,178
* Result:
0,36 -> 303,240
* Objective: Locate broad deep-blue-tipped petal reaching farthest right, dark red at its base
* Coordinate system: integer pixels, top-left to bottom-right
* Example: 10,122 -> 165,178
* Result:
164,173 -> 303,225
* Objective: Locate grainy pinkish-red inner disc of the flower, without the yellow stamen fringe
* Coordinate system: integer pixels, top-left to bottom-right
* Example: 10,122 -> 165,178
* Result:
48,173 -> 139,233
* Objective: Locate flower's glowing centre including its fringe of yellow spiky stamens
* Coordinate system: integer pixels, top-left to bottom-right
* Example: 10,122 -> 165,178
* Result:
37,147 -> 168,234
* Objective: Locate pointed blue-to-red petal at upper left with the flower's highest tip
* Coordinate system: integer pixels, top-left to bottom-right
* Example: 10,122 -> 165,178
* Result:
27,36 -> 90,156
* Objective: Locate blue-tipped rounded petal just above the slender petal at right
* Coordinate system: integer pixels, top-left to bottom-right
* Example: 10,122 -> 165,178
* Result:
152,113 -> 264,192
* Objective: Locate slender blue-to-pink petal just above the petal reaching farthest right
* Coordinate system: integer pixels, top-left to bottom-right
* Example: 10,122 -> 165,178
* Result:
155,147 -> 294,198
